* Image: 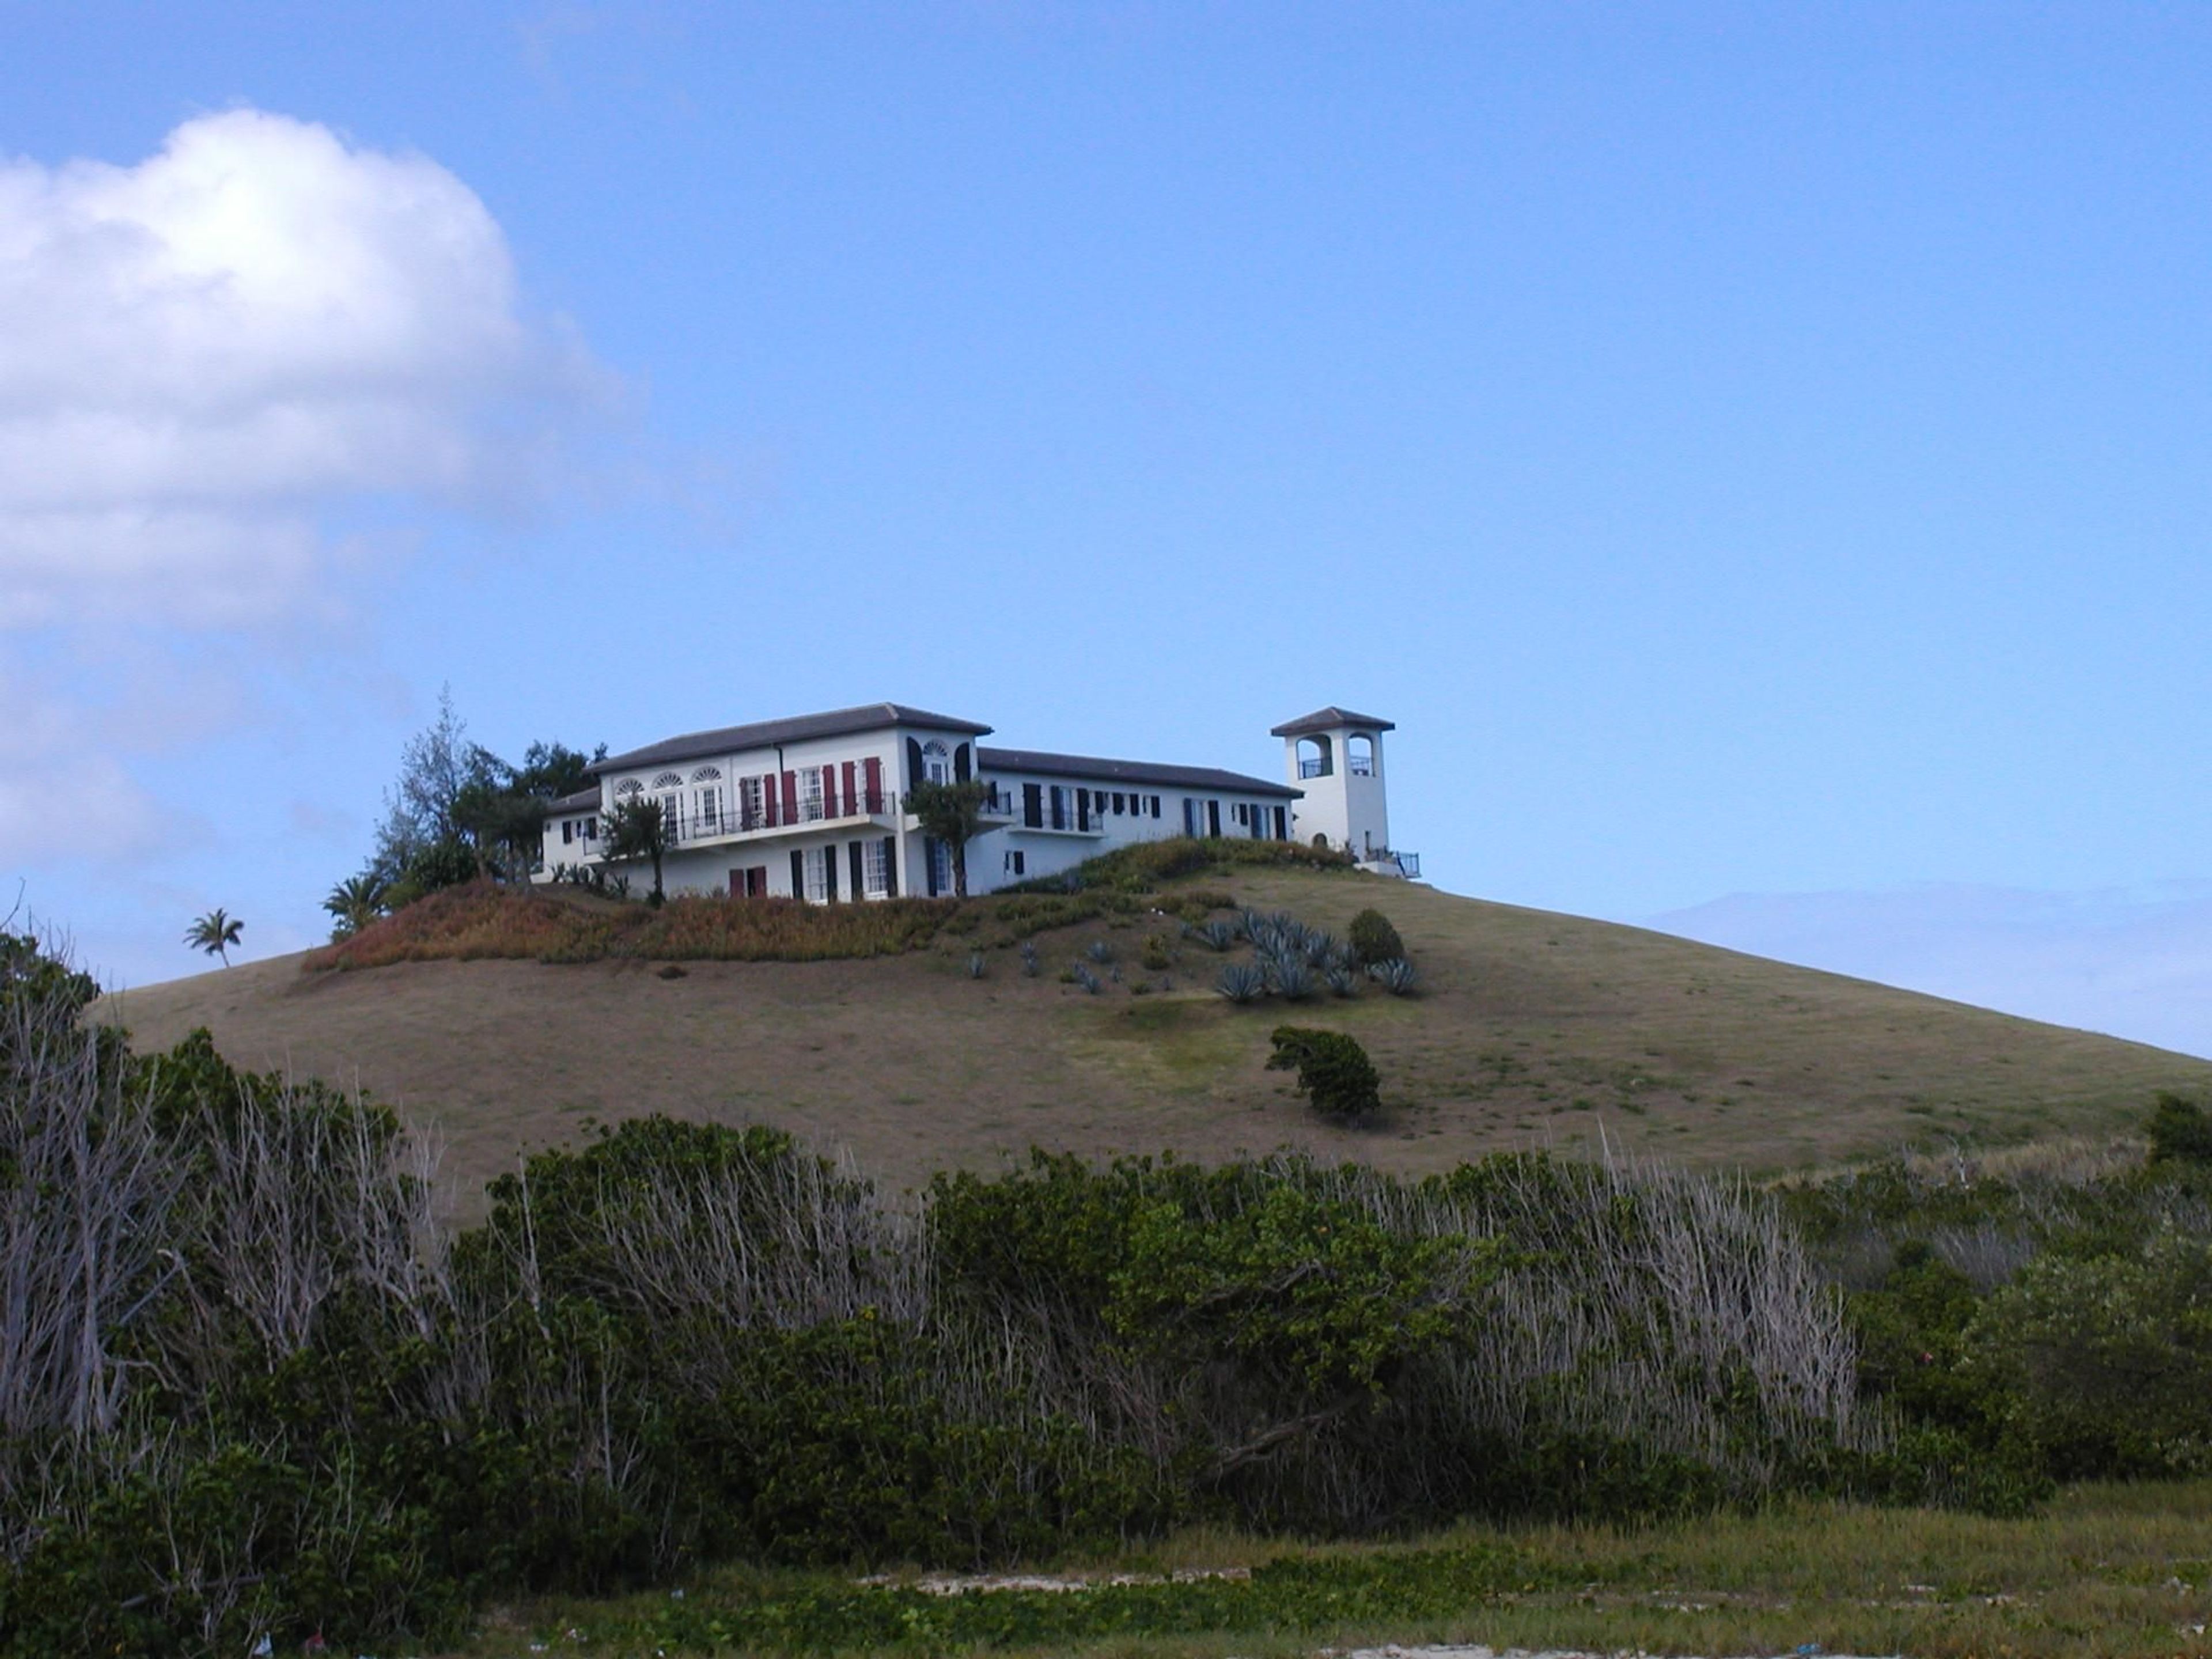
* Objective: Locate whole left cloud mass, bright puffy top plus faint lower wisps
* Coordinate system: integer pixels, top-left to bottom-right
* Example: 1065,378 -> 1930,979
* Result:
0,108 -> 615,863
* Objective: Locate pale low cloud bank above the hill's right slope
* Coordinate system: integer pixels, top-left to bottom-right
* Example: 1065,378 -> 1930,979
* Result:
1650,880 -> 2212,1055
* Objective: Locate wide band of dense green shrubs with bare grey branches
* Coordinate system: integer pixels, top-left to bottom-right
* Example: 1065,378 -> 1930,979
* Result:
21,940 -> 2207,1654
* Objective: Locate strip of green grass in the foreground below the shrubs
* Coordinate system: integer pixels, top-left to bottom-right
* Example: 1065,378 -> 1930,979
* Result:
467,1482 -> 2212,1659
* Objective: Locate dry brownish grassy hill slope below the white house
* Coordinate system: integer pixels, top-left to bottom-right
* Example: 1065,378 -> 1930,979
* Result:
100,869 -> 2212,1208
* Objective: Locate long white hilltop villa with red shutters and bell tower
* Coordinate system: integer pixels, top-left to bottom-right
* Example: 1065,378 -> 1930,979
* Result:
537,703 -> 1398,903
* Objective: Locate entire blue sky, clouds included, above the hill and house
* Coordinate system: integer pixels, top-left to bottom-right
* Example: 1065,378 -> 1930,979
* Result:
0,0 -> 2212,1053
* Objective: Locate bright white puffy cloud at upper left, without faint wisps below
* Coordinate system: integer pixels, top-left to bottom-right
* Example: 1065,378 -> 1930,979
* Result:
0,108 -> 608,628
